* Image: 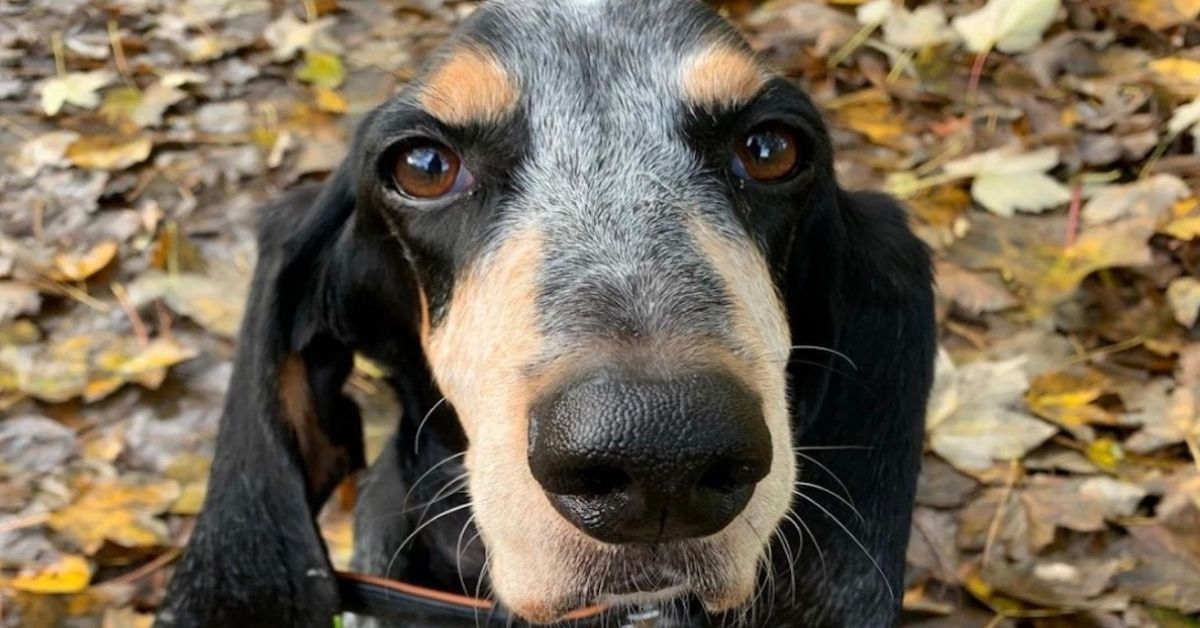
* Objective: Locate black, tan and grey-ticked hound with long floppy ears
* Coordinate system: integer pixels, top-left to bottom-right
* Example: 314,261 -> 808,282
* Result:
157,0 -> 936,627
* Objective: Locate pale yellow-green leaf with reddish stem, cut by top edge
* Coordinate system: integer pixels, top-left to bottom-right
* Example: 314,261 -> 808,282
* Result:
953,0 -> 1060,53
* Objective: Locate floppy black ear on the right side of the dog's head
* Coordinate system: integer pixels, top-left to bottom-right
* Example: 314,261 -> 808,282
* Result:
775,184 -> 936,626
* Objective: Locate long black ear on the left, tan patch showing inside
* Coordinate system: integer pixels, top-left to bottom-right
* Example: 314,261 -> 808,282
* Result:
157,166 -> 362,628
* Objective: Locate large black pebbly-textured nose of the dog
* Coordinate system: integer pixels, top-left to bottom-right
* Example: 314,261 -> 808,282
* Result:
529,373 -> 770,543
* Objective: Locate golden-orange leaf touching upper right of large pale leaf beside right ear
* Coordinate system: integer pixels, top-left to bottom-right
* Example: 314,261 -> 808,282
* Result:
1025,369 -> 1116,427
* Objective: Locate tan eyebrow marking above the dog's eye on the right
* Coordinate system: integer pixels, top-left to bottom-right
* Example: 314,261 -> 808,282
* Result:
680,42 -> 768,107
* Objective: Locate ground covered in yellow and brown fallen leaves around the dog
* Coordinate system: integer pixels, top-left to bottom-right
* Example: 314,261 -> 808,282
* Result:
0,0 -> 1200,628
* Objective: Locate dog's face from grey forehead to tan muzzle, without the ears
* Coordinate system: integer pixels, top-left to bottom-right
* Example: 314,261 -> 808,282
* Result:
353,0 -> 833,621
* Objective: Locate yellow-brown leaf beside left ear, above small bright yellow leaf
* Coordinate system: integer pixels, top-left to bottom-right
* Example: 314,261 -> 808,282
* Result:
47,479 -> 179,555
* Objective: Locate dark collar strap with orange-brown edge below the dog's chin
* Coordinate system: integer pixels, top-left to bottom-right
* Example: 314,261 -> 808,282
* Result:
337,572 -> 607,626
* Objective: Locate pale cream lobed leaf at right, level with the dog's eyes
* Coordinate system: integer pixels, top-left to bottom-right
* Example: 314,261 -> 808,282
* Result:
944,147 -> 1070,216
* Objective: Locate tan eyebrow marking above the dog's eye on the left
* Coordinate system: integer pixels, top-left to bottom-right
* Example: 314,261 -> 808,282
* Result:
418,46 -> 520,125
